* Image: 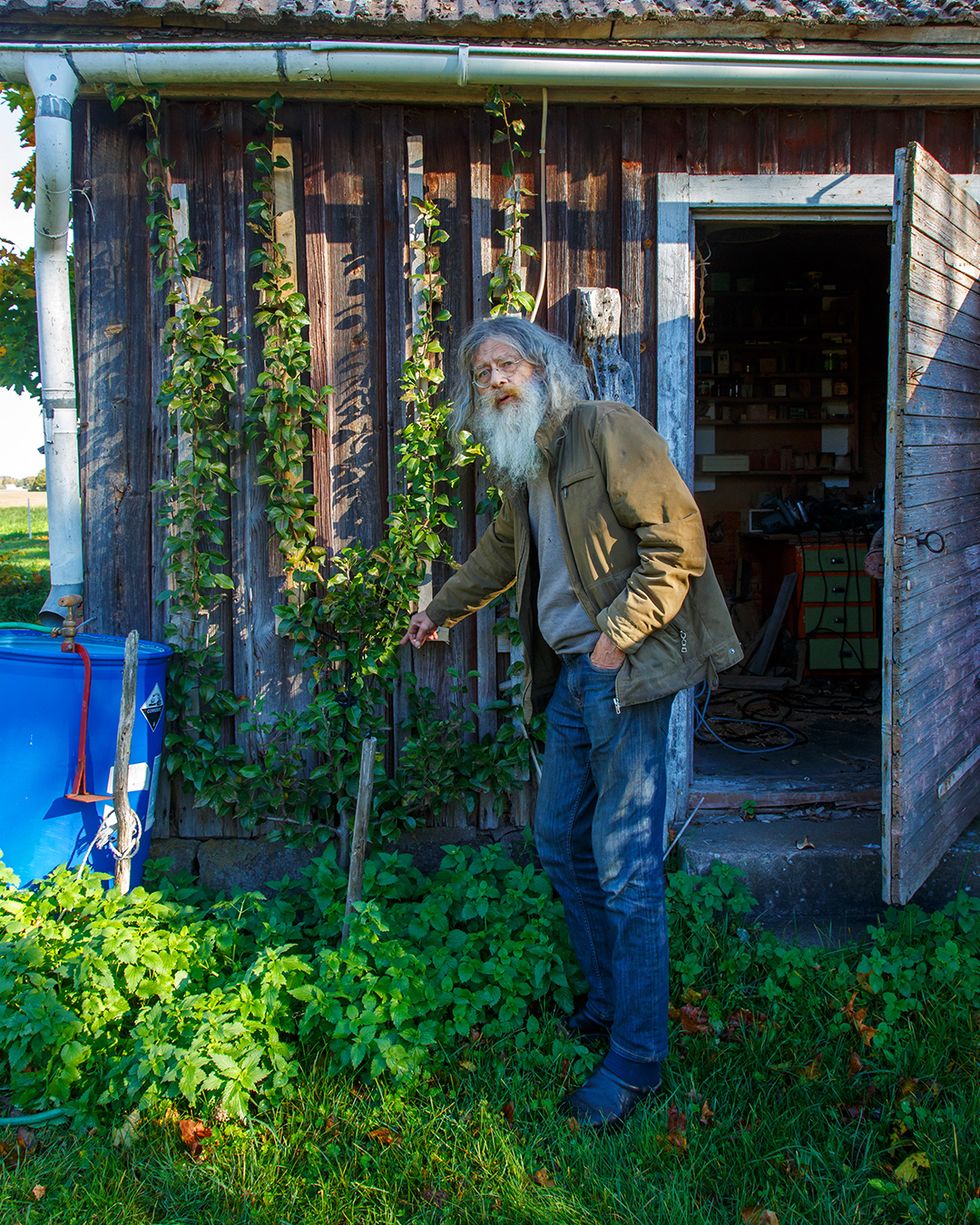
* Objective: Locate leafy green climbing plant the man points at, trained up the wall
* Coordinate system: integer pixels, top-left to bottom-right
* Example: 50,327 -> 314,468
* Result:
113,92 -> 527,840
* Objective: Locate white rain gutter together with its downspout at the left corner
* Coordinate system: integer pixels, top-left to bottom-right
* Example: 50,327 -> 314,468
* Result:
9,40 -> 980,614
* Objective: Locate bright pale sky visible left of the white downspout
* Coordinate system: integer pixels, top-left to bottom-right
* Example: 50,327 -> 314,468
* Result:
0,103 -> 44,477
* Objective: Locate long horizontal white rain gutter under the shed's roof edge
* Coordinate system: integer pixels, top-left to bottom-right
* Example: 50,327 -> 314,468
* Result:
0,40 -> 980,96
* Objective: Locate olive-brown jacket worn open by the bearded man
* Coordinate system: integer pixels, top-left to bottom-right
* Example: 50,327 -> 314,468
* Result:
425,401 -> 742,715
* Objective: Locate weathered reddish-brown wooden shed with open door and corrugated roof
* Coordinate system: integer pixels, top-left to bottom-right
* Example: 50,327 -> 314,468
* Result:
0,0 -> 980,902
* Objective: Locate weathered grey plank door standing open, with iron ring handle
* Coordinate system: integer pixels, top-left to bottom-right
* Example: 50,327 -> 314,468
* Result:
882,145 -> 980,904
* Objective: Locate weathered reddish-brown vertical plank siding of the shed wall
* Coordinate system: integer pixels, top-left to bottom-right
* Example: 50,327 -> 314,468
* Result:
75,102 -> 980,834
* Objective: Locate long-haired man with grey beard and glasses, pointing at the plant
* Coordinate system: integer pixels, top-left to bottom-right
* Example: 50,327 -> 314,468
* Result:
402,317 -> 741,1128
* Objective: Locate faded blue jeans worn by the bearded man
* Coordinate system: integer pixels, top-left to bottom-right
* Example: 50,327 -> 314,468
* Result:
534,655 -> 673,1062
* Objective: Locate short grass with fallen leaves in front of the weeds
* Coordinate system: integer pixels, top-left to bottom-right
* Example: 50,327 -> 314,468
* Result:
0,1024 -> 980,1225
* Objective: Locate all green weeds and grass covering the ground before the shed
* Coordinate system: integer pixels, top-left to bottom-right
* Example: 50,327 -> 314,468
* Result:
0,848 -> 980,1225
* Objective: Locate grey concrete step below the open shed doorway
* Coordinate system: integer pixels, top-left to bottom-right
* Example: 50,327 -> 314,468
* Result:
681,815 -> 980,930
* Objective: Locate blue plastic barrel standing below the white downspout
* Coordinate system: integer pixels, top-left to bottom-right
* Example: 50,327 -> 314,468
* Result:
0,628 -> 173,884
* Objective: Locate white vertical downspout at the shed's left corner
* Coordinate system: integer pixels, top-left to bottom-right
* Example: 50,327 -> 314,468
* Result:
25,54 -> 83,621
